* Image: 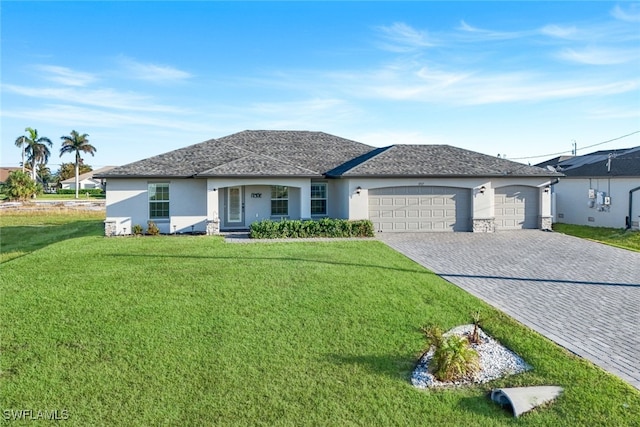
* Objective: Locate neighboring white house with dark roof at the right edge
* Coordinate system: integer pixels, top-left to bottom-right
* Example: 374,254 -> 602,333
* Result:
538,147 -> 640,229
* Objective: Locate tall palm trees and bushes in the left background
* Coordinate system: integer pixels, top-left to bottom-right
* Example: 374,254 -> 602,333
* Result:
3,127 -> 97,200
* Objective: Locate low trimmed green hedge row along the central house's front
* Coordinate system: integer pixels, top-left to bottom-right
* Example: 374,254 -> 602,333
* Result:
249,218 -> 374,239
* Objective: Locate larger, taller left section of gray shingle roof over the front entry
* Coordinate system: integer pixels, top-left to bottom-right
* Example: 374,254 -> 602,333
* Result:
104,130 -> 373,178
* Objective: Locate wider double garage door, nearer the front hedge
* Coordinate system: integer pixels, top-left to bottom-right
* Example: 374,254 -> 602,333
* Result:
369,187 -> 471,232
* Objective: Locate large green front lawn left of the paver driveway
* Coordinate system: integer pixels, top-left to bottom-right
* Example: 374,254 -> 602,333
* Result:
0,212 -> 640,426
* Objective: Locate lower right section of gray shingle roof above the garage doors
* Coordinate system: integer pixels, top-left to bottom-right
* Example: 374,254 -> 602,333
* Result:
342,145 -> 562,177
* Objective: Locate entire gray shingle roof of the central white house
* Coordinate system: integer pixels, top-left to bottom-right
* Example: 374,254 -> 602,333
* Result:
103,130 -> 561,178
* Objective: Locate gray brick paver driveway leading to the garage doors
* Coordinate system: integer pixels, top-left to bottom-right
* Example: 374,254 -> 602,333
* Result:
378,230 -> 640,389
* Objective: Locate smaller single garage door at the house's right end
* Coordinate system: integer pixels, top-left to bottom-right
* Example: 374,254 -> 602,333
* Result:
495,185 -> 540,230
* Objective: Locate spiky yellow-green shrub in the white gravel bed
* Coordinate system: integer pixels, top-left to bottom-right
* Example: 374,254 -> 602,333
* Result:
423,326 -> 480,381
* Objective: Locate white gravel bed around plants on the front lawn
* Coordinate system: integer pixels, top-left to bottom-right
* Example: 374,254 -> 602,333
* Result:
411,325 -> 531,389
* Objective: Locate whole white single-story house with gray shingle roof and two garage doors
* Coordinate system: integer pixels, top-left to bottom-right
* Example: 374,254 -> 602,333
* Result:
100,131 -> 562,235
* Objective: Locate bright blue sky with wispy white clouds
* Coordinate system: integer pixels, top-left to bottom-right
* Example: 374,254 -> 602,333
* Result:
0,1 -> 640,171
